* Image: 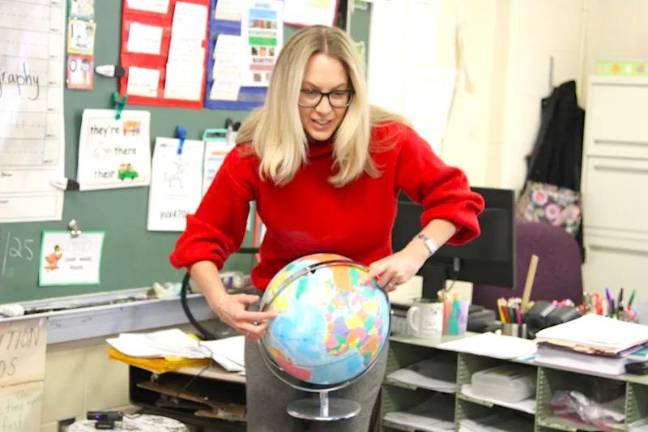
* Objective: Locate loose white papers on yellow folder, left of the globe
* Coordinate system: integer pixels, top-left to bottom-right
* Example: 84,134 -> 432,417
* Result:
106,329 -> 245,372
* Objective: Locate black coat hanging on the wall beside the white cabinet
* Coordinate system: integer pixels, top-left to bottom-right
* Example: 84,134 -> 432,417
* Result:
527,81 -> 585,191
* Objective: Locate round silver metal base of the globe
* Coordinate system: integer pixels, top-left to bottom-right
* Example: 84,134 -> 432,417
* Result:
287,391 -> 360,421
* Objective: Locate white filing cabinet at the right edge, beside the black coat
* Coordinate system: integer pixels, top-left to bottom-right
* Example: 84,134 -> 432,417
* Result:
581,76 -> 648,322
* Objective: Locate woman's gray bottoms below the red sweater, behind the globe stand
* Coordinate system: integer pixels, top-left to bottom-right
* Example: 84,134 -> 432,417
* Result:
245,339 -> 388,432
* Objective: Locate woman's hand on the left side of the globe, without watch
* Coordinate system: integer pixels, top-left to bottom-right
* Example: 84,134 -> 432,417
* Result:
212,294 -> 277,341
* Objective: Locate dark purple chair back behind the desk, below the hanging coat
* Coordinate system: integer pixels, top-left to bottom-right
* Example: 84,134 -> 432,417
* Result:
472,220 -> 583,310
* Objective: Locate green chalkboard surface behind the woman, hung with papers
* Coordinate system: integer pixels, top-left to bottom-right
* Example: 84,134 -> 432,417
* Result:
0,0 -> 369,303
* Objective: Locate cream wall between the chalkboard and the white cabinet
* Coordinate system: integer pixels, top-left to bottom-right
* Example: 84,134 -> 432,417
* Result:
390,0 -> 648,190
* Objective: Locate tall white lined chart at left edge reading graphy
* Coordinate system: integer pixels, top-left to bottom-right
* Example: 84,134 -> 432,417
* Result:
0,0 -> 65,222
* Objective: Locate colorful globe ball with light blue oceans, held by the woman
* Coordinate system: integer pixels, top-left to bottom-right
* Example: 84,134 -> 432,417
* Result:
261,254 -> 390,388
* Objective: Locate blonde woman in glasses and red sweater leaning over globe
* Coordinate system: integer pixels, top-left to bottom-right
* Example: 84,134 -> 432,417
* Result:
171,26 -> 483,432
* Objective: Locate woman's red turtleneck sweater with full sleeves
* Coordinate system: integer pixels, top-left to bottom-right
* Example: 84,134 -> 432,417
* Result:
171,123 -> 484,290
